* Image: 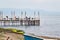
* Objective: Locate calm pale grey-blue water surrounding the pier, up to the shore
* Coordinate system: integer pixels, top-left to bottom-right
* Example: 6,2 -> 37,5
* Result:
0,16 -> 60,37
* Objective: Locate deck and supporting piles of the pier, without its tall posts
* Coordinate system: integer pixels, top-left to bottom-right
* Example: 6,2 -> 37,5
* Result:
0,18 -> 40,26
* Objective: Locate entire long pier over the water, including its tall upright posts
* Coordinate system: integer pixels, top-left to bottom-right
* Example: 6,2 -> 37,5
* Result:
0,12 -> 40,26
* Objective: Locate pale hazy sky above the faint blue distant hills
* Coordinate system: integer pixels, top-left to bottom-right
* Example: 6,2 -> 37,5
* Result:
0,0 -> 60,11
